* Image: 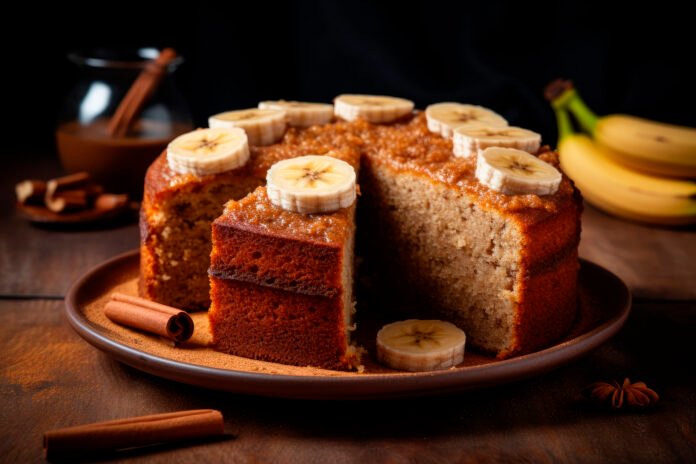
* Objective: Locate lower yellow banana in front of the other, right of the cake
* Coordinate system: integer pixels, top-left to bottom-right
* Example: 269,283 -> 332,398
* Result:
556,108 -> 696,225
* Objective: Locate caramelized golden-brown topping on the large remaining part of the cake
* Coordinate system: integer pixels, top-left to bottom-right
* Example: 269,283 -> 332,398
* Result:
145,112 -> 580,227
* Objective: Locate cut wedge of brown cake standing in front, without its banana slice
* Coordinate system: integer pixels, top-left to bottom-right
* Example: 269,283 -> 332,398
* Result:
209,154 -> 360,370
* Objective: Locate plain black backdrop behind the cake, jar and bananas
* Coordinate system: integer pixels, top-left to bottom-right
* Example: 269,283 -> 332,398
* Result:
3,0 -> 696,152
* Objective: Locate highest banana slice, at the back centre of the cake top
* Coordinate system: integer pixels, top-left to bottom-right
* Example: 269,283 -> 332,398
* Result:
334,94 -> 414,123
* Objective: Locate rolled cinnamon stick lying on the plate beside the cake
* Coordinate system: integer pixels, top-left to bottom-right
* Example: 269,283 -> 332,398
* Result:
104,292 -> 193,342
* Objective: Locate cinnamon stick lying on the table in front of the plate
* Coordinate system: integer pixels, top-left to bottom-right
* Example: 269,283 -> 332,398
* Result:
43,409 -> 224,459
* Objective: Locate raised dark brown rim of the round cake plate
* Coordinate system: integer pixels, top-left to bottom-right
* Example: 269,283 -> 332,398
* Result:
64,249 -> 632,400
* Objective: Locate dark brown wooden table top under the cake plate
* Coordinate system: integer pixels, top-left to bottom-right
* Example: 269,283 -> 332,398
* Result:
0,157 -> 696,464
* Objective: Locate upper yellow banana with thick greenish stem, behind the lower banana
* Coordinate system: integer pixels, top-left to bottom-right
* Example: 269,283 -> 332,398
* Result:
550,81 -> 696,178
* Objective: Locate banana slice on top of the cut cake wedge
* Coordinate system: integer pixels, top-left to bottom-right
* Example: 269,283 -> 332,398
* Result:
266,155 -> 356,214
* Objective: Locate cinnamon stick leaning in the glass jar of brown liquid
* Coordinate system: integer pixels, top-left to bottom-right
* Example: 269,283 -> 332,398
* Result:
107,48 -> 176,137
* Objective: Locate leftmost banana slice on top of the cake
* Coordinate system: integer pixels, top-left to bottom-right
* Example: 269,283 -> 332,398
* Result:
167,127 -> 249,176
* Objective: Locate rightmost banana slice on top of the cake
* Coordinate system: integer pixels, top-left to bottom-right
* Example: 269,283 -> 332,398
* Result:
476,147 -> 561,195
